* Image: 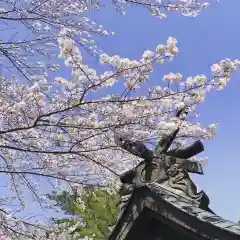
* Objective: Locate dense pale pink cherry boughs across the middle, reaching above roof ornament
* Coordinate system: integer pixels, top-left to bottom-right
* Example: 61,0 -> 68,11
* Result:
0,32 -> 239,239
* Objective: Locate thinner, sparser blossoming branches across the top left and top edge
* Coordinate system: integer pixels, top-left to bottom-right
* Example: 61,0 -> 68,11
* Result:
0,0 -> 212,78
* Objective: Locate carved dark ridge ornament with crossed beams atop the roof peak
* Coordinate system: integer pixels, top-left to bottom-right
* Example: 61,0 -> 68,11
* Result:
115,108 -> 211,214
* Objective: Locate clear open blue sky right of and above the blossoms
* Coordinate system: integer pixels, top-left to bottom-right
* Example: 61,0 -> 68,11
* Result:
86,0 -> 240,221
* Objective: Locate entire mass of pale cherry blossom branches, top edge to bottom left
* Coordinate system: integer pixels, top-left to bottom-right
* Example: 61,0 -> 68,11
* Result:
0,0 -> 236,240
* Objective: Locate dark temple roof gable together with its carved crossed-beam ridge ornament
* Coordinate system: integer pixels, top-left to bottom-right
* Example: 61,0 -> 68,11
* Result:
108,109 -> 240,240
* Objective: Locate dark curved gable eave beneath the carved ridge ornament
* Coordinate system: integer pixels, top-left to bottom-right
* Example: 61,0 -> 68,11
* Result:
108,183 -> 240,240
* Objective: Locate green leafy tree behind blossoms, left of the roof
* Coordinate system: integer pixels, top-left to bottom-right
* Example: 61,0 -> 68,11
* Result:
48,188 -> 119,240
